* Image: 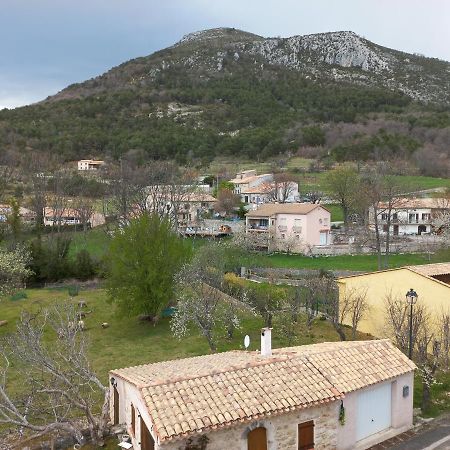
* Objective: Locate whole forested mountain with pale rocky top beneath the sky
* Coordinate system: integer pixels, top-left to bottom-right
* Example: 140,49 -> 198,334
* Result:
0,28 -> 450,172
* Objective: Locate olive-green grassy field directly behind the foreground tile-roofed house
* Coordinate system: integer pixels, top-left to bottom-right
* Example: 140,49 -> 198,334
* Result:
0,289 -> 450,422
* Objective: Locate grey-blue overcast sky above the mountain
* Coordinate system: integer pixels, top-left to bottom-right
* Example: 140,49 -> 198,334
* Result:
0,0 -> 450,109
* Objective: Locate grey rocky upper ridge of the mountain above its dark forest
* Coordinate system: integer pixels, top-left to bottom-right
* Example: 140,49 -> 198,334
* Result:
56,28 -> 450,104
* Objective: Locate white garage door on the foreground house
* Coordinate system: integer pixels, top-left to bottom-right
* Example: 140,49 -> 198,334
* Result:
356,383 -> 392,441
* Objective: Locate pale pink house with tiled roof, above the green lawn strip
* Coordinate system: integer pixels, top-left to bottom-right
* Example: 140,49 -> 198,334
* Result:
245,203 -> 331,253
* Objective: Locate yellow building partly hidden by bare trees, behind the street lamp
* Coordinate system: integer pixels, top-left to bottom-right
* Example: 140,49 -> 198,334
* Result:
338,262 -> 450,337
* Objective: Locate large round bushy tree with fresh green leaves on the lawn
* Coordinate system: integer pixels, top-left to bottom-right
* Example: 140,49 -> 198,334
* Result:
106,214 -> 189,320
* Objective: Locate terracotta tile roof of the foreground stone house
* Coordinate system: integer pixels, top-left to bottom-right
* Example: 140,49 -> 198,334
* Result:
111,340 -> 415,442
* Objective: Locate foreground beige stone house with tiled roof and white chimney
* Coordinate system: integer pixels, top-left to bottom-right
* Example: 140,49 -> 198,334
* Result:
110,336 -> 415,450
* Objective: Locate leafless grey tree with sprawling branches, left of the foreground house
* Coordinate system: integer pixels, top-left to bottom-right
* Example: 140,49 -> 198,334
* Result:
0,306 -> 109,445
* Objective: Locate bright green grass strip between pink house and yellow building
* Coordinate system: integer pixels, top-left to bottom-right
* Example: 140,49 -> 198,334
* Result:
253,253 -> 446,272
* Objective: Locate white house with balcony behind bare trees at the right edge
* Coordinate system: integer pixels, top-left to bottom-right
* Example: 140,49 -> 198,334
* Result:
369,198 -> 450,236
